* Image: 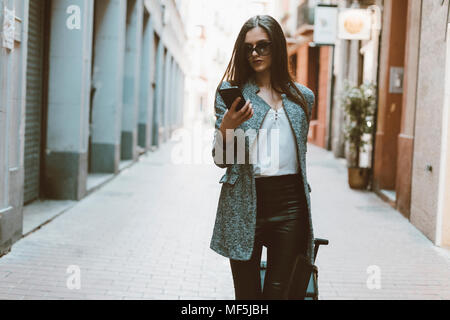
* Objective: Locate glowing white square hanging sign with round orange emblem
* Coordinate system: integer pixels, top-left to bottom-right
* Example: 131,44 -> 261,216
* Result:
338,9 -> 372,40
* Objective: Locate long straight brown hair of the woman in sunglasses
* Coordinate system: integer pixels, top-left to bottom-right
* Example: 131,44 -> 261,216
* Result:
219,15 -> 310,123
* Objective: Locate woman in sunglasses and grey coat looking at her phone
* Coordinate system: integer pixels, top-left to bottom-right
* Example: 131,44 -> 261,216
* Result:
210,15 -> 314,300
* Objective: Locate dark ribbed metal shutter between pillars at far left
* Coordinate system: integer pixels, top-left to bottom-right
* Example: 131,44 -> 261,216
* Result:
24,0 -> 44,203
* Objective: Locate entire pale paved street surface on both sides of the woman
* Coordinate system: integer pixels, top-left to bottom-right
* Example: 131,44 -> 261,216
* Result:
0,123 -> 450,300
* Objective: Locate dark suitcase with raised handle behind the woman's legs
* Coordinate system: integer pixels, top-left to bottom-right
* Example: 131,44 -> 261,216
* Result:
260,238 -> 328,300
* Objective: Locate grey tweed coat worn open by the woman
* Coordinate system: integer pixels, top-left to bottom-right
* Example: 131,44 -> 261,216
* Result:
210,78 -> 315,264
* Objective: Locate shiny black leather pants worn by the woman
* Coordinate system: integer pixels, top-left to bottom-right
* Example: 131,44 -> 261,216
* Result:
230,174 -> 308,300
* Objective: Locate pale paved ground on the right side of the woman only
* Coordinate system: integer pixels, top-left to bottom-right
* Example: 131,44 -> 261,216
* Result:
307,146 -> 450,299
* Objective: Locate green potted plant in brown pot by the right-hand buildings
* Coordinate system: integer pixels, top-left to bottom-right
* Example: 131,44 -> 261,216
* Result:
342,81 -> 376,189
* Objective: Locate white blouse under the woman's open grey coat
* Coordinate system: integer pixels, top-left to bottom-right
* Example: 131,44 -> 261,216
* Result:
213,107 -> 300,178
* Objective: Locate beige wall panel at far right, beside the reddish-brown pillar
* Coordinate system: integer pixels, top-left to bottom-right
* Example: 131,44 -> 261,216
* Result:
410,1 -> 447,243
